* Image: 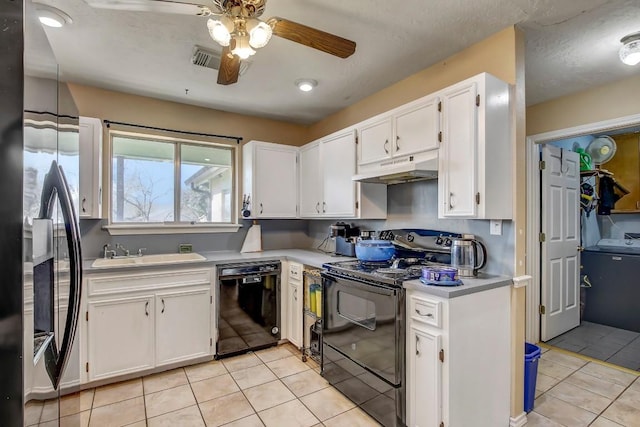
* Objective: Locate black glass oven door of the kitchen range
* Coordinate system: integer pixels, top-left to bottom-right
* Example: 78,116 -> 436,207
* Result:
322,273 -> 403,386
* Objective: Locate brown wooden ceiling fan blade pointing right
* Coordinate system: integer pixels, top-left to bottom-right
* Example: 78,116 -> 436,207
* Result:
267,16 -> 356,58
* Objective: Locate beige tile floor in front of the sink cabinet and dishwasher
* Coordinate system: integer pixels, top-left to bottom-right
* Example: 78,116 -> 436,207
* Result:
25,344 -> 379,427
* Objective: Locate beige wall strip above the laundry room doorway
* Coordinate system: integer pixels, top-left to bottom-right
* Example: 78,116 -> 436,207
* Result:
527,75 -> 640,135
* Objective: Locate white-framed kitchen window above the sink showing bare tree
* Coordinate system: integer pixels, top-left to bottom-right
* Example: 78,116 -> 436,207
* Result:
110,131 -> 234,226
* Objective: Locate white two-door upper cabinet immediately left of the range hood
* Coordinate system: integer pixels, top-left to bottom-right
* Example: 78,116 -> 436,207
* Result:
300,129 -> 387,218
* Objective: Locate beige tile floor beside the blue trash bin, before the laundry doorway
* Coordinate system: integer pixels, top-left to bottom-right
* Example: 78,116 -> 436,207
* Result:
527,348 -> 640,427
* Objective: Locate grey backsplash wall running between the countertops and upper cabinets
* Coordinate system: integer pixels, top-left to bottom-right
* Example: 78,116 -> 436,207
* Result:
80,181 -> 514,275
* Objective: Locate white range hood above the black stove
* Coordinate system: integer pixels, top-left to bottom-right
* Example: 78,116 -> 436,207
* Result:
351,154 -> 438,185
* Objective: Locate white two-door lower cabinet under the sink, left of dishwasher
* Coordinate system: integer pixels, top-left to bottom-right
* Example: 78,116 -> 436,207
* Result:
80,268 -> 212,381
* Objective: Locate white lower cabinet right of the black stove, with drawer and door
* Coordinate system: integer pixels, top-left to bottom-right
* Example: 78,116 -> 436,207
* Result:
406,286 -> 511,427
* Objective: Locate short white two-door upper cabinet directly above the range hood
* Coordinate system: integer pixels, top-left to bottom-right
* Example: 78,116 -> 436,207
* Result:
357,95 -> 440,173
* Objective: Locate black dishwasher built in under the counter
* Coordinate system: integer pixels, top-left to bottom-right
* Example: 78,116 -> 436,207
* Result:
215,261 -> 281,359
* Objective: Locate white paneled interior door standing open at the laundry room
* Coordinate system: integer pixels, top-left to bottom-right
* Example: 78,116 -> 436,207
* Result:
540,144 -> 580,341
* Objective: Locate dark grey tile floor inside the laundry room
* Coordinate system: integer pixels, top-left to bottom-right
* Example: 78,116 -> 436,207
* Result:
547,321 -> 640,371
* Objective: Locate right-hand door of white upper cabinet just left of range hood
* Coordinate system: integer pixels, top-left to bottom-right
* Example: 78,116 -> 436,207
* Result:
321,131 -> 356,217
